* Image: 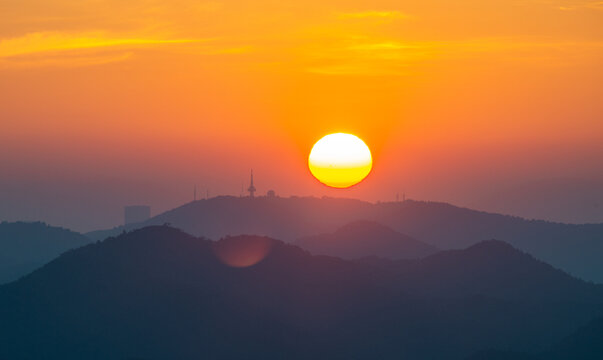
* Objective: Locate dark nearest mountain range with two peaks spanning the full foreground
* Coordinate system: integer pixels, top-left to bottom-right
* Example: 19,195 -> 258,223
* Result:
0,226 -> 603,360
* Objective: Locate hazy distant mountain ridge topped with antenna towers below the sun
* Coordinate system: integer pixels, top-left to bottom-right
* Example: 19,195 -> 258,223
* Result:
86,196 -> 603,283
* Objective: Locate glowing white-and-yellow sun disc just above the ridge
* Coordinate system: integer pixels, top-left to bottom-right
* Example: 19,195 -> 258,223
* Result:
308,133 -> 373,188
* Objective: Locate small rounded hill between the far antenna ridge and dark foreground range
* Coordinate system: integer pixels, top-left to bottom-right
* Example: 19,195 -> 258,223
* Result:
295,220 -> 438,259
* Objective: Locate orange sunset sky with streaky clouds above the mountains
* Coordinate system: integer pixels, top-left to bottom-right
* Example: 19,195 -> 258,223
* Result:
0,0 -> 603,231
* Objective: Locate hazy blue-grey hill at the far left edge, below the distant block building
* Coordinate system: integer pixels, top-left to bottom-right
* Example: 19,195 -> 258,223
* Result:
0,222 -> 90,284
